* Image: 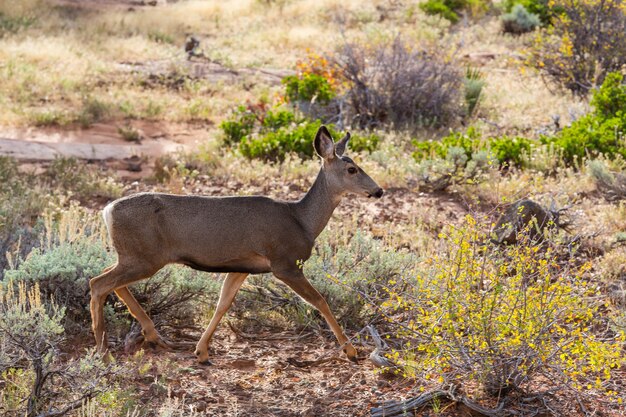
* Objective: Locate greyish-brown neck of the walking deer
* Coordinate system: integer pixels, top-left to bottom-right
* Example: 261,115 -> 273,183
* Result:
295,170 -> 341,239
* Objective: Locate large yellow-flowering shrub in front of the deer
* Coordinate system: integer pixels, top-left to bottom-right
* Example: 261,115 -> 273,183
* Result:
381,216 -> 624,408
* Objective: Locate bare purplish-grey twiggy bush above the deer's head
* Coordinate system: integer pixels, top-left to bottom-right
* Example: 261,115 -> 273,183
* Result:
334,37 -> 463,128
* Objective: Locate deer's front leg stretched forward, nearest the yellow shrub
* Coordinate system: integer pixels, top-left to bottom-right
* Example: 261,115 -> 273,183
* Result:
274,265 -> 357,362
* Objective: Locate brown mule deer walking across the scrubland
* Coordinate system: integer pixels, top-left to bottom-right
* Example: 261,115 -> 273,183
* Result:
89,126 -> 383,365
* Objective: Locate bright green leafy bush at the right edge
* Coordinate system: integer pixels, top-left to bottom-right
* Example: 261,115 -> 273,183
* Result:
543,73 -> 626,164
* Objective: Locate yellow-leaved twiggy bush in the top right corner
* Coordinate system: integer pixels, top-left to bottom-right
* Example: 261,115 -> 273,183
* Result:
529,0 -> 626,95
